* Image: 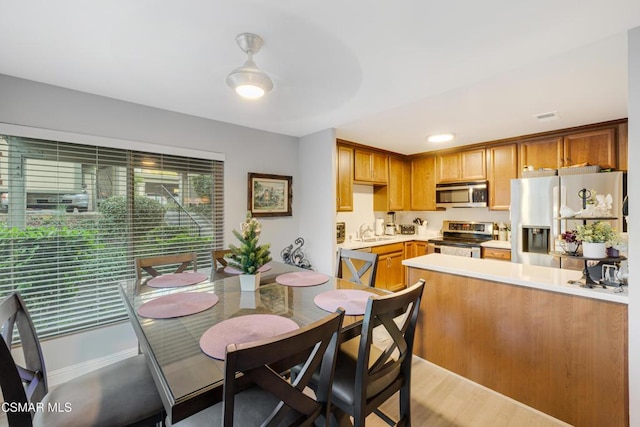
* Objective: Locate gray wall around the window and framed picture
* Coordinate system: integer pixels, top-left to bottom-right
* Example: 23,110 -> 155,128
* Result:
0,74 -> 335,371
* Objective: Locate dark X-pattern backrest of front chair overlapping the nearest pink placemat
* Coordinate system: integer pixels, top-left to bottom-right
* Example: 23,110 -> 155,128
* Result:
222,309 -> 344,427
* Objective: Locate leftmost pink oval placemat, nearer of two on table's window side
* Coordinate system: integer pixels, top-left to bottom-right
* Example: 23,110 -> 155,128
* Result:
138,292 -> 218,319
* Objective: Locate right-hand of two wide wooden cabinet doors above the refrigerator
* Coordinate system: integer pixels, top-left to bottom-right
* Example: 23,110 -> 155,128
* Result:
564,129 -> 618,168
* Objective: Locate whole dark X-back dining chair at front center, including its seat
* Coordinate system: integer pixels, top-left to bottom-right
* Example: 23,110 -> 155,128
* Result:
167,309 -> 344,427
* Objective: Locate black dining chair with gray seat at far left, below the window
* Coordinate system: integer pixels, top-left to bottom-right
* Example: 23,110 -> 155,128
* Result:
0,292 -> 164,427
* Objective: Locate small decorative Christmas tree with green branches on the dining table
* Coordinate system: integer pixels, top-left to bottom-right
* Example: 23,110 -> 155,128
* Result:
228,211 -> 271,274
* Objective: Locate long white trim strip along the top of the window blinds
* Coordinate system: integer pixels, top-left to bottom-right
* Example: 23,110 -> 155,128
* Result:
0,122 -> 225,161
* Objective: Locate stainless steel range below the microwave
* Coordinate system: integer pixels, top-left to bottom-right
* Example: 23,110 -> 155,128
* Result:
427,221 -> 494,258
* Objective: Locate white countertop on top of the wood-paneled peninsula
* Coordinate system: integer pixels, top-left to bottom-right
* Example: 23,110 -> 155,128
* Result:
402,254 -> 629,304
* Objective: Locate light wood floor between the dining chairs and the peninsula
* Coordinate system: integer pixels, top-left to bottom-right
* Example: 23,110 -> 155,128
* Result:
367,357 -> 569,427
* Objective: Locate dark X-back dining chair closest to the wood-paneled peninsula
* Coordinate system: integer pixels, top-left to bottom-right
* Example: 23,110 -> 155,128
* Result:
332,279 -> 425,426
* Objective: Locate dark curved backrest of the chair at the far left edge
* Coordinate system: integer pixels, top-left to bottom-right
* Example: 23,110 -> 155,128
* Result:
0,292 -> 48,426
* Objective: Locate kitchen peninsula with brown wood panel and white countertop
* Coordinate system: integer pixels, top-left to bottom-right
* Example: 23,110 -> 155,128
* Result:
403,254 -> 629,426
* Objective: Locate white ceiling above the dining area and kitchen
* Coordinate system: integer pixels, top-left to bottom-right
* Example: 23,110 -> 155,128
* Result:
0,0 -> 640,154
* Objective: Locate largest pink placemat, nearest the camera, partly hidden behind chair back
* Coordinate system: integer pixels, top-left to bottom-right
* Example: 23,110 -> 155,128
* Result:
200,314 -> 299,360
